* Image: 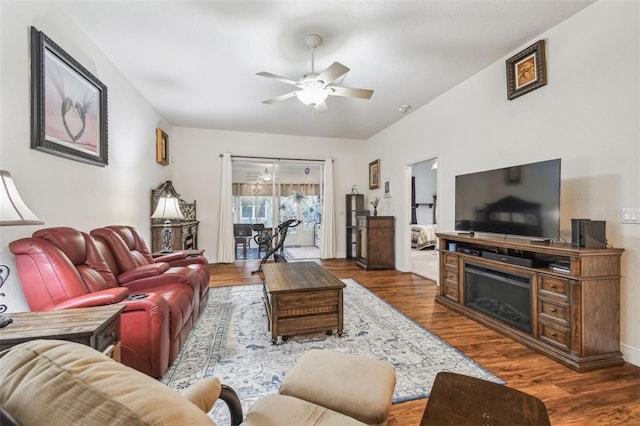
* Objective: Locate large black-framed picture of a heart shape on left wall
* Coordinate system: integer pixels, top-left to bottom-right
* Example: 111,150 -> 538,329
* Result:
31,27 -> 109,167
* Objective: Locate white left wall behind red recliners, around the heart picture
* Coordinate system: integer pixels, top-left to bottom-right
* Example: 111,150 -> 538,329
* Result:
0,1 -> 171,312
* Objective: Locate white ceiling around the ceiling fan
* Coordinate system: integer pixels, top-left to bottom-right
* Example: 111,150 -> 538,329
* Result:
56,0 -> 592,139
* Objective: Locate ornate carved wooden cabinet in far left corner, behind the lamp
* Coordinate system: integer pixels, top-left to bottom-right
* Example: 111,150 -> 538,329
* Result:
151,180 -> 199,252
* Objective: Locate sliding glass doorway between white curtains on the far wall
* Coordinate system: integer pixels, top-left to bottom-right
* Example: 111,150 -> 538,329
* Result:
232,159 -> 324,260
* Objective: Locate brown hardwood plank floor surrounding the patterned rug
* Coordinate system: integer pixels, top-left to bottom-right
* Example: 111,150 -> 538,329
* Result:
211,260 -> 640,426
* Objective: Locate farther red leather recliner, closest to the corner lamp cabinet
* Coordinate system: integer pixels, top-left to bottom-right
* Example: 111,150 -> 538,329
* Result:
91,225 -> 209,320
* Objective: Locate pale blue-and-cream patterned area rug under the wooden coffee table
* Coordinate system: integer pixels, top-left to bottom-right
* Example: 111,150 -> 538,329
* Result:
162,279 -> 504,425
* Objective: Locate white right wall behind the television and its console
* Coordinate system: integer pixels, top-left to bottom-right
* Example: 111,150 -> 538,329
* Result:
369,1 -> 640,365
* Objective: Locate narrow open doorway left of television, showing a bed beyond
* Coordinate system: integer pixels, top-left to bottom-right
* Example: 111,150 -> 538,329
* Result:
410,157 -> 439,282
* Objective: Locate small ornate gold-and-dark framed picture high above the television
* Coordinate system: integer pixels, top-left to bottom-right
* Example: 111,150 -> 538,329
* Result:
506,40 -> 547,100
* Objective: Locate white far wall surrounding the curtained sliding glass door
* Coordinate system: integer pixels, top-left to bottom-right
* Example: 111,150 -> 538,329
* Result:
172,127 -> 369,262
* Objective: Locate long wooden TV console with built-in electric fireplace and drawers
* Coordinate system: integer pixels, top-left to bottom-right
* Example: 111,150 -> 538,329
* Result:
436,233 -> 624,371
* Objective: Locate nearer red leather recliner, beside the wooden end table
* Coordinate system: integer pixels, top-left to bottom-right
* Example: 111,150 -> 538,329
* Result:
9,227 -> 204,377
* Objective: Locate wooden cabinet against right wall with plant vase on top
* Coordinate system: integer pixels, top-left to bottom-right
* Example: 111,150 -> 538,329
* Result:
356,216 -> 396,269
